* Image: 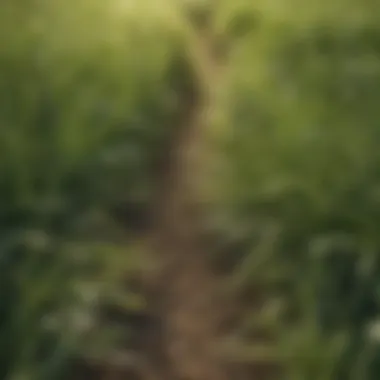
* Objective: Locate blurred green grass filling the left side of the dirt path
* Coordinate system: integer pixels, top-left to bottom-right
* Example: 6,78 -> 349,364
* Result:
0,0 -> 187,379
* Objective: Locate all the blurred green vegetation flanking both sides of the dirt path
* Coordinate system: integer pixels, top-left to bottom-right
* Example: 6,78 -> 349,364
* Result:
0,0 -> 380,380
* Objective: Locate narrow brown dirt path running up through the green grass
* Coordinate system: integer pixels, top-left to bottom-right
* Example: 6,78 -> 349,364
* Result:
140,10 -> 227,380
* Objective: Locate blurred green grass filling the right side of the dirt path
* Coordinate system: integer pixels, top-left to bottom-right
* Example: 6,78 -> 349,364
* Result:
217,1 -> 380,379
